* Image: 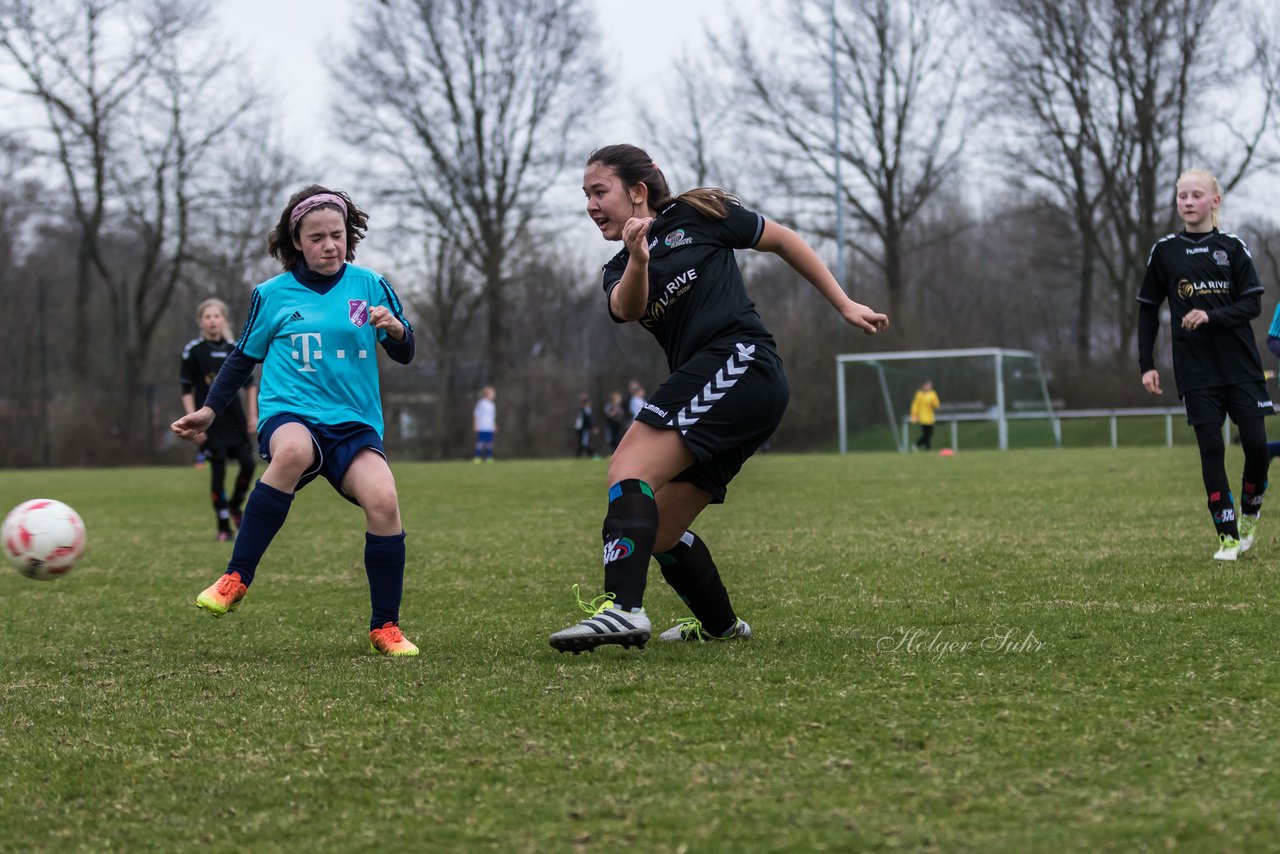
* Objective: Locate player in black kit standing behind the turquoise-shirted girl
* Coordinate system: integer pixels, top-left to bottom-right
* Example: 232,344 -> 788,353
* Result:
180,300 -> 257,542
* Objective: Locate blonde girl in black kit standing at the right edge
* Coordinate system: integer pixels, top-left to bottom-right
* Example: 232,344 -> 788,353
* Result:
1138,169 -> 1272,561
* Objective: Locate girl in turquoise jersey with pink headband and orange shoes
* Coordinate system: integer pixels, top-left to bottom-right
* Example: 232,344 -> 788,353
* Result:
173,184 -> 417,656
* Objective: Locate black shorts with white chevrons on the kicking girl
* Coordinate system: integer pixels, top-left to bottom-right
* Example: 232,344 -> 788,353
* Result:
636,341 -> 791,504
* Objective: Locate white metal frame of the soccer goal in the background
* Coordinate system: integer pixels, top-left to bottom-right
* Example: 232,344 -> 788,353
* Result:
836,347 -> 1060,455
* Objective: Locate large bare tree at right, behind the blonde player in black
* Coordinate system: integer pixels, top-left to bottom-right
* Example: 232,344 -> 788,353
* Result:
982,0 -> 1277,366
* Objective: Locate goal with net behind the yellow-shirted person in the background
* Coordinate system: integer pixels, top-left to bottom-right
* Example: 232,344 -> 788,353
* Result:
836,347 -> 1061,453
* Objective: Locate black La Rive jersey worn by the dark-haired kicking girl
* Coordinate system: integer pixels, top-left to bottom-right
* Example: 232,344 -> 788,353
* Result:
604,201 -> 773,370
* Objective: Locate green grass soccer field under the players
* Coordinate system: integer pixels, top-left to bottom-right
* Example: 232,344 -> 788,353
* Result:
0,447 -> 1280,851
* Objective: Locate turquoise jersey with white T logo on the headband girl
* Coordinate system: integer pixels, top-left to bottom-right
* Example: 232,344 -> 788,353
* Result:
239,264 -> 412,435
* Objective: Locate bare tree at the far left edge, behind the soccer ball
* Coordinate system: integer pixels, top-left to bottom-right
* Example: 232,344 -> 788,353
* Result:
0,0 -> 264,458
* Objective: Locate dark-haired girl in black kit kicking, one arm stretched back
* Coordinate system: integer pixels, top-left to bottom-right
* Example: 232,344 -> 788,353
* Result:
550,145 -> 888,653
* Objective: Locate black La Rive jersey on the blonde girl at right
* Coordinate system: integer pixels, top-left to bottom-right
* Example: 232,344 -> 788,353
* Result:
1138,229 -> 1263,397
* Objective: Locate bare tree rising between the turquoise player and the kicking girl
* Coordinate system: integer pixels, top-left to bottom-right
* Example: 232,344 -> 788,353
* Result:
342,0 -> 603,374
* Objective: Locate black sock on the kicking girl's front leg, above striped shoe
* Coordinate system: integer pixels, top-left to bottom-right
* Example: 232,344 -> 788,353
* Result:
600,480 -> 658,611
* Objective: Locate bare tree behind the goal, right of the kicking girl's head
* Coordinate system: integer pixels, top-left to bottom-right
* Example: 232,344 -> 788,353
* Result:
717,0 -> 966,315
